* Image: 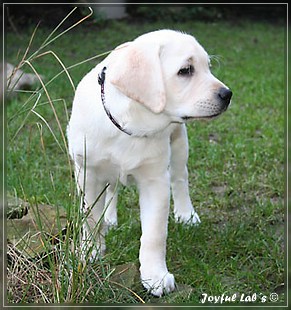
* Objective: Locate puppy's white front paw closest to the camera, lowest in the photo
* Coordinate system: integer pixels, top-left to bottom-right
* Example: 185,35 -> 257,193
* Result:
141,272 -> 175,297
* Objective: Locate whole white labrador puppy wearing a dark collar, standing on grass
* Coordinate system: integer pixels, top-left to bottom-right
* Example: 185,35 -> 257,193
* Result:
67,30 -> 232,296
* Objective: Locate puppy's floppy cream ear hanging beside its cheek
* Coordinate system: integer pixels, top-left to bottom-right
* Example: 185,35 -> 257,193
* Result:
108,41 -> 166,113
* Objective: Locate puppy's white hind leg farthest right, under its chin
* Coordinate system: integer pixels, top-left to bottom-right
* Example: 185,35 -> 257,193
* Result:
170,125 -> 200,224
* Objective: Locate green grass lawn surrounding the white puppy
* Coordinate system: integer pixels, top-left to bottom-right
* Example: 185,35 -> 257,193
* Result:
6,11 -> 286,305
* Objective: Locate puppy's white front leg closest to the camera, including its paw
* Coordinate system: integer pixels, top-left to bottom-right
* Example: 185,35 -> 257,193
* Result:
139,173 -> 175,296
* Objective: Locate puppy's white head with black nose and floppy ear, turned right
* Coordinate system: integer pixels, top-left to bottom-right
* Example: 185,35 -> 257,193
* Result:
110,30 -> 232,121
